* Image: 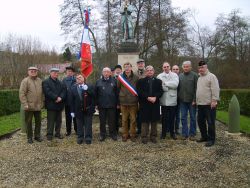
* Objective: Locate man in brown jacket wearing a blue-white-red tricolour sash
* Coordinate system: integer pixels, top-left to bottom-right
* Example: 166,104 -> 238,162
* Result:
117,62 -> 138,142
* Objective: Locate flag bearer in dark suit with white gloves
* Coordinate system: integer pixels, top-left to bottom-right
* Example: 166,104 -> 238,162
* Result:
70,74 -> 95,144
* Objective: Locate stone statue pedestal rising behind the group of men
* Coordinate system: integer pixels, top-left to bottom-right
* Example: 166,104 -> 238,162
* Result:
117,42 -> 139,72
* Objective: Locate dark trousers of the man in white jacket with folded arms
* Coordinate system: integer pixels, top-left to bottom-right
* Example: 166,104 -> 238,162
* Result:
161,106 -> 176,138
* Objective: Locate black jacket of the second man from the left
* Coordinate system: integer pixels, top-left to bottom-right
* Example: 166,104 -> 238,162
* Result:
42,77 -> 66,111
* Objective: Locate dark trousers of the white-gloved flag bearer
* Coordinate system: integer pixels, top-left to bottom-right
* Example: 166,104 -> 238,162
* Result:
76,114 -> 93,141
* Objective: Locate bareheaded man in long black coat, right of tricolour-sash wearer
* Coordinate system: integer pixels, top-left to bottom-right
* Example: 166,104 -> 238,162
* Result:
137,65 -> 163,144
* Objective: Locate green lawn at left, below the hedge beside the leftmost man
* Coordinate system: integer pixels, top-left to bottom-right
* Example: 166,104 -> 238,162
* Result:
0,110 -> 47,136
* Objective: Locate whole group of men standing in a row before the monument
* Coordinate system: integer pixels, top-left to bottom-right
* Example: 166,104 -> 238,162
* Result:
19,59 -> 220,146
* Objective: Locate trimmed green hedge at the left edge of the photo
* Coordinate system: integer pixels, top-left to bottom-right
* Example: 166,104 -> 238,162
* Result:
0,90 -> 20,116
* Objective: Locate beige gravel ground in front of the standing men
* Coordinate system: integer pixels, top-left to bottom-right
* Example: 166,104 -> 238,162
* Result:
0,117 -> 250,188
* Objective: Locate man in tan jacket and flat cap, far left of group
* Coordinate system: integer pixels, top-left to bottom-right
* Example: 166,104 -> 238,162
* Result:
19,67 -> 43,144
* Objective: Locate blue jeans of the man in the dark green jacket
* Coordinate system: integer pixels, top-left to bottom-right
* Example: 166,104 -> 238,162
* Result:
180,102 -> 196,137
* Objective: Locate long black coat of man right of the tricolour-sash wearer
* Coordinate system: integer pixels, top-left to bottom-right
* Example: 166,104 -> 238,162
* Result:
136,77 -> 163,122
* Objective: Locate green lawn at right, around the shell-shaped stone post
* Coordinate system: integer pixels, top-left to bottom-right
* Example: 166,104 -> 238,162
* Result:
216,111 -> 250,133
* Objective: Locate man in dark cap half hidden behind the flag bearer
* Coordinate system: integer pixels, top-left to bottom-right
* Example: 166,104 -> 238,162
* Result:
62,66 -> 77,136
